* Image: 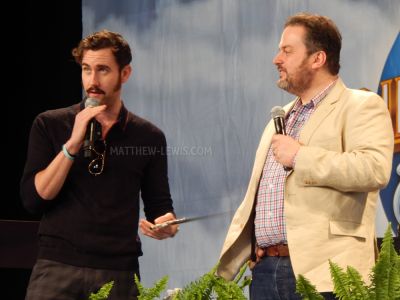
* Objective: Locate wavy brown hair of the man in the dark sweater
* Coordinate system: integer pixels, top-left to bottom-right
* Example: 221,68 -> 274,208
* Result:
72,29 -> 132,70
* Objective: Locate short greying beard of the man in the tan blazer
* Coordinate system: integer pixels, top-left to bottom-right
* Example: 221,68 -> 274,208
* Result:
276,58 -> 314,96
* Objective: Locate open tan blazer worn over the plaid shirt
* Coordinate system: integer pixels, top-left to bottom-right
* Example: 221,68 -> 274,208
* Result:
217,79 -> 393,292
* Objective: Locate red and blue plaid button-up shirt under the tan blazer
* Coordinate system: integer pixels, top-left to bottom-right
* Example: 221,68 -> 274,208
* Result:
254,80 -> 336,247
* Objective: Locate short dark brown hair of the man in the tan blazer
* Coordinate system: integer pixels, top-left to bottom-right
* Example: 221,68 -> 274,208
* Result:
285,13 -> 342,75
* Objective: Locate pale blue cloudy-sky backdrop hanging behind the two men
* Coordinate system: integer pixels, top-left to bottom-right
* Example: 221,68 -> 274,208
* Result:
83,0 -> 400,288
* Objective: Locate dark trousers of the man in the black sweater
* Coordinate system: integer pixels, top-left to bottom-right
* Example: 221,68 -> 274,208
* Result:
25,259 -> 139,300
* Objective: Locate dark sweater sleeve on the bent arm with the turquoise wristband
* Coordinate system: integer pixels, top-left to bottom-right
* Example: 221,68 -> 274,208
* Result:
20,114 -> 57,213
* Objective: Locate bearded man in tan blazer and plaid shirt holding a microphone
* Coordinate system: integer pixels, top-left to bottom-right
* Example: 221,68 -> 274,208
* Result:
217,13 -> 393,300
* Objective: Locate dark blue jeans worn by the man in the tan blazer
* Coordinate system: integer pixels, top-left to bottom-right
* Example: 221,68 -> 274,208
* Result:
250,256 -> 335,300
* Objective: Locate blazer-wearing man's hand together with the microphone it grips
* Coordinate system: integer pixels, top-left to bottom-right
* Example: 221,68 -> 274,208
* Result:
271,106 -> 300,171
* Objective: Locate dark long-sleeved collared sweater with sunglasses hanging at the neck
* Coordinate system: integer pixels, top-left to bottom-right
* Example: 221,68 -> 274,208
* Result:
21,102 -> 173,270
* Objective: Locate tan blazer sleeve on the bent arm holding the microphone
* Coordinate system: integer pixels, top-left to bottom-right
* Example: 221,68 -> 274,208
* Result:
294,93 -> 394,192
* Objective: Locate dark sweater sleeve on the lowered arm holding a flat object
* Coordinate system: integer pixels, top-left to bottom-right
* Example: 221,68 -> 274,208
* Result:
141,131 -> 173,222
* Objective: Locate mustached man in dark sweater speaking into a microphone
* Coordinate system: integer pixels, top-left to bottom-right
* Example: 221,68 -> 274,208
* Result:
21,30 -> 178,300
